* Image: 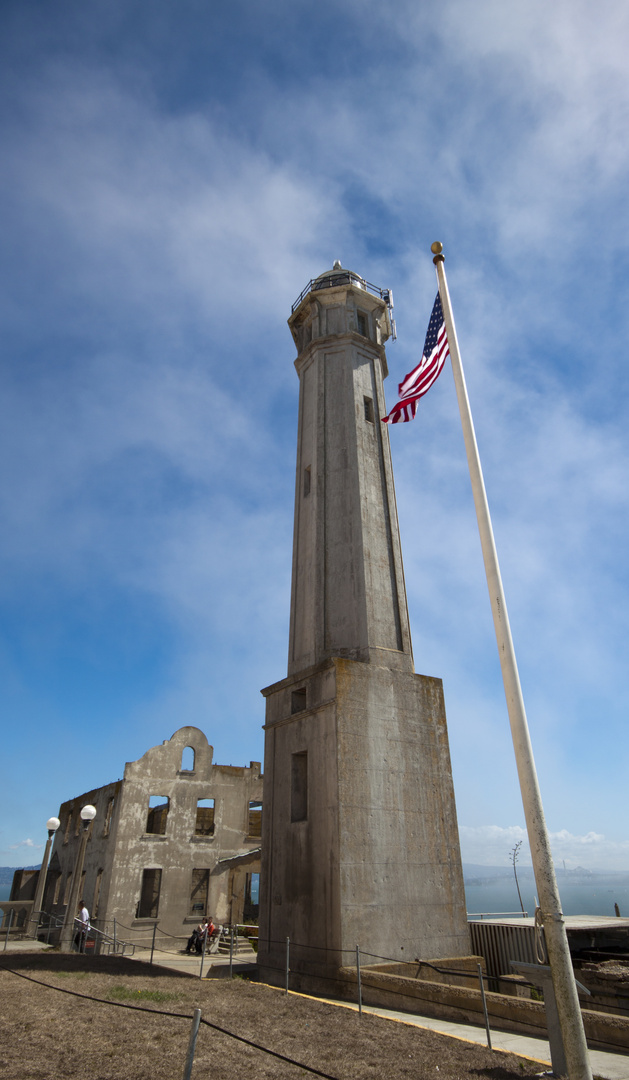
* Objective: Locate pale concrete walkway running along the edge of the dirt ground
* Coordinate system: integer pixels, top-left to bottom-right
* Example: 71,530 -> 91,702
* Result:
6,941 -> 629,1080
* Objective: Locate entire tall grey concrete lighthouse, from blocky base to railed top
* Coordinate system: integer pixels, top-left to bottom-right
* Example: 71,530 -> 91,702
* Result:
258,264 -> 469,985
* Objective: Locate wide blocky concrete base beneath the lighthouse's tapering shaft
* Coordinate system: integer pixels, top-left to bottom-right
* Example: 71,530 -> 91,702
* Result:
258,658 -> 470,982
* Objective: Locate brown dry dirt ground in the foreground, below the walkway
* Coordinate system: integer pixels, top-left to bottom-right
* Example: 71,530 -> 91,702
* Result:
0,953 -> 546,1080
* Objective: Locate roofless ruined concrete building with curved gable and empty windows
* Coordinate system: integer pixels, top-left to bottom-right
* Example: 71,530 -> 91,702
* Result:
42,727 -> 263,937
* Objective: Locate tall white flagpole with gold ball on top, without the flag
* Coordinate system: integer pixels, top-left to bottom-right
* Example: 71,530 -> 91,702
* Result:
431,242 -> 592,1080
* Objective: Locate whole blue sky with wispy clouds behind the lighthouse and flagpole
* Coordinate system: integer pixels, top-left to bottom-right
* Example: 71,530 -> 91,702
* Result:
0,0 -> 629,869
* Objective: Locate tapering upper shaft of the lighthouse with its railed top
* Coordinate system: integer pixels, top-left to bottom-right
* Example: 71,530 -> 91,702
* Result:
289,271 -> 413,674
